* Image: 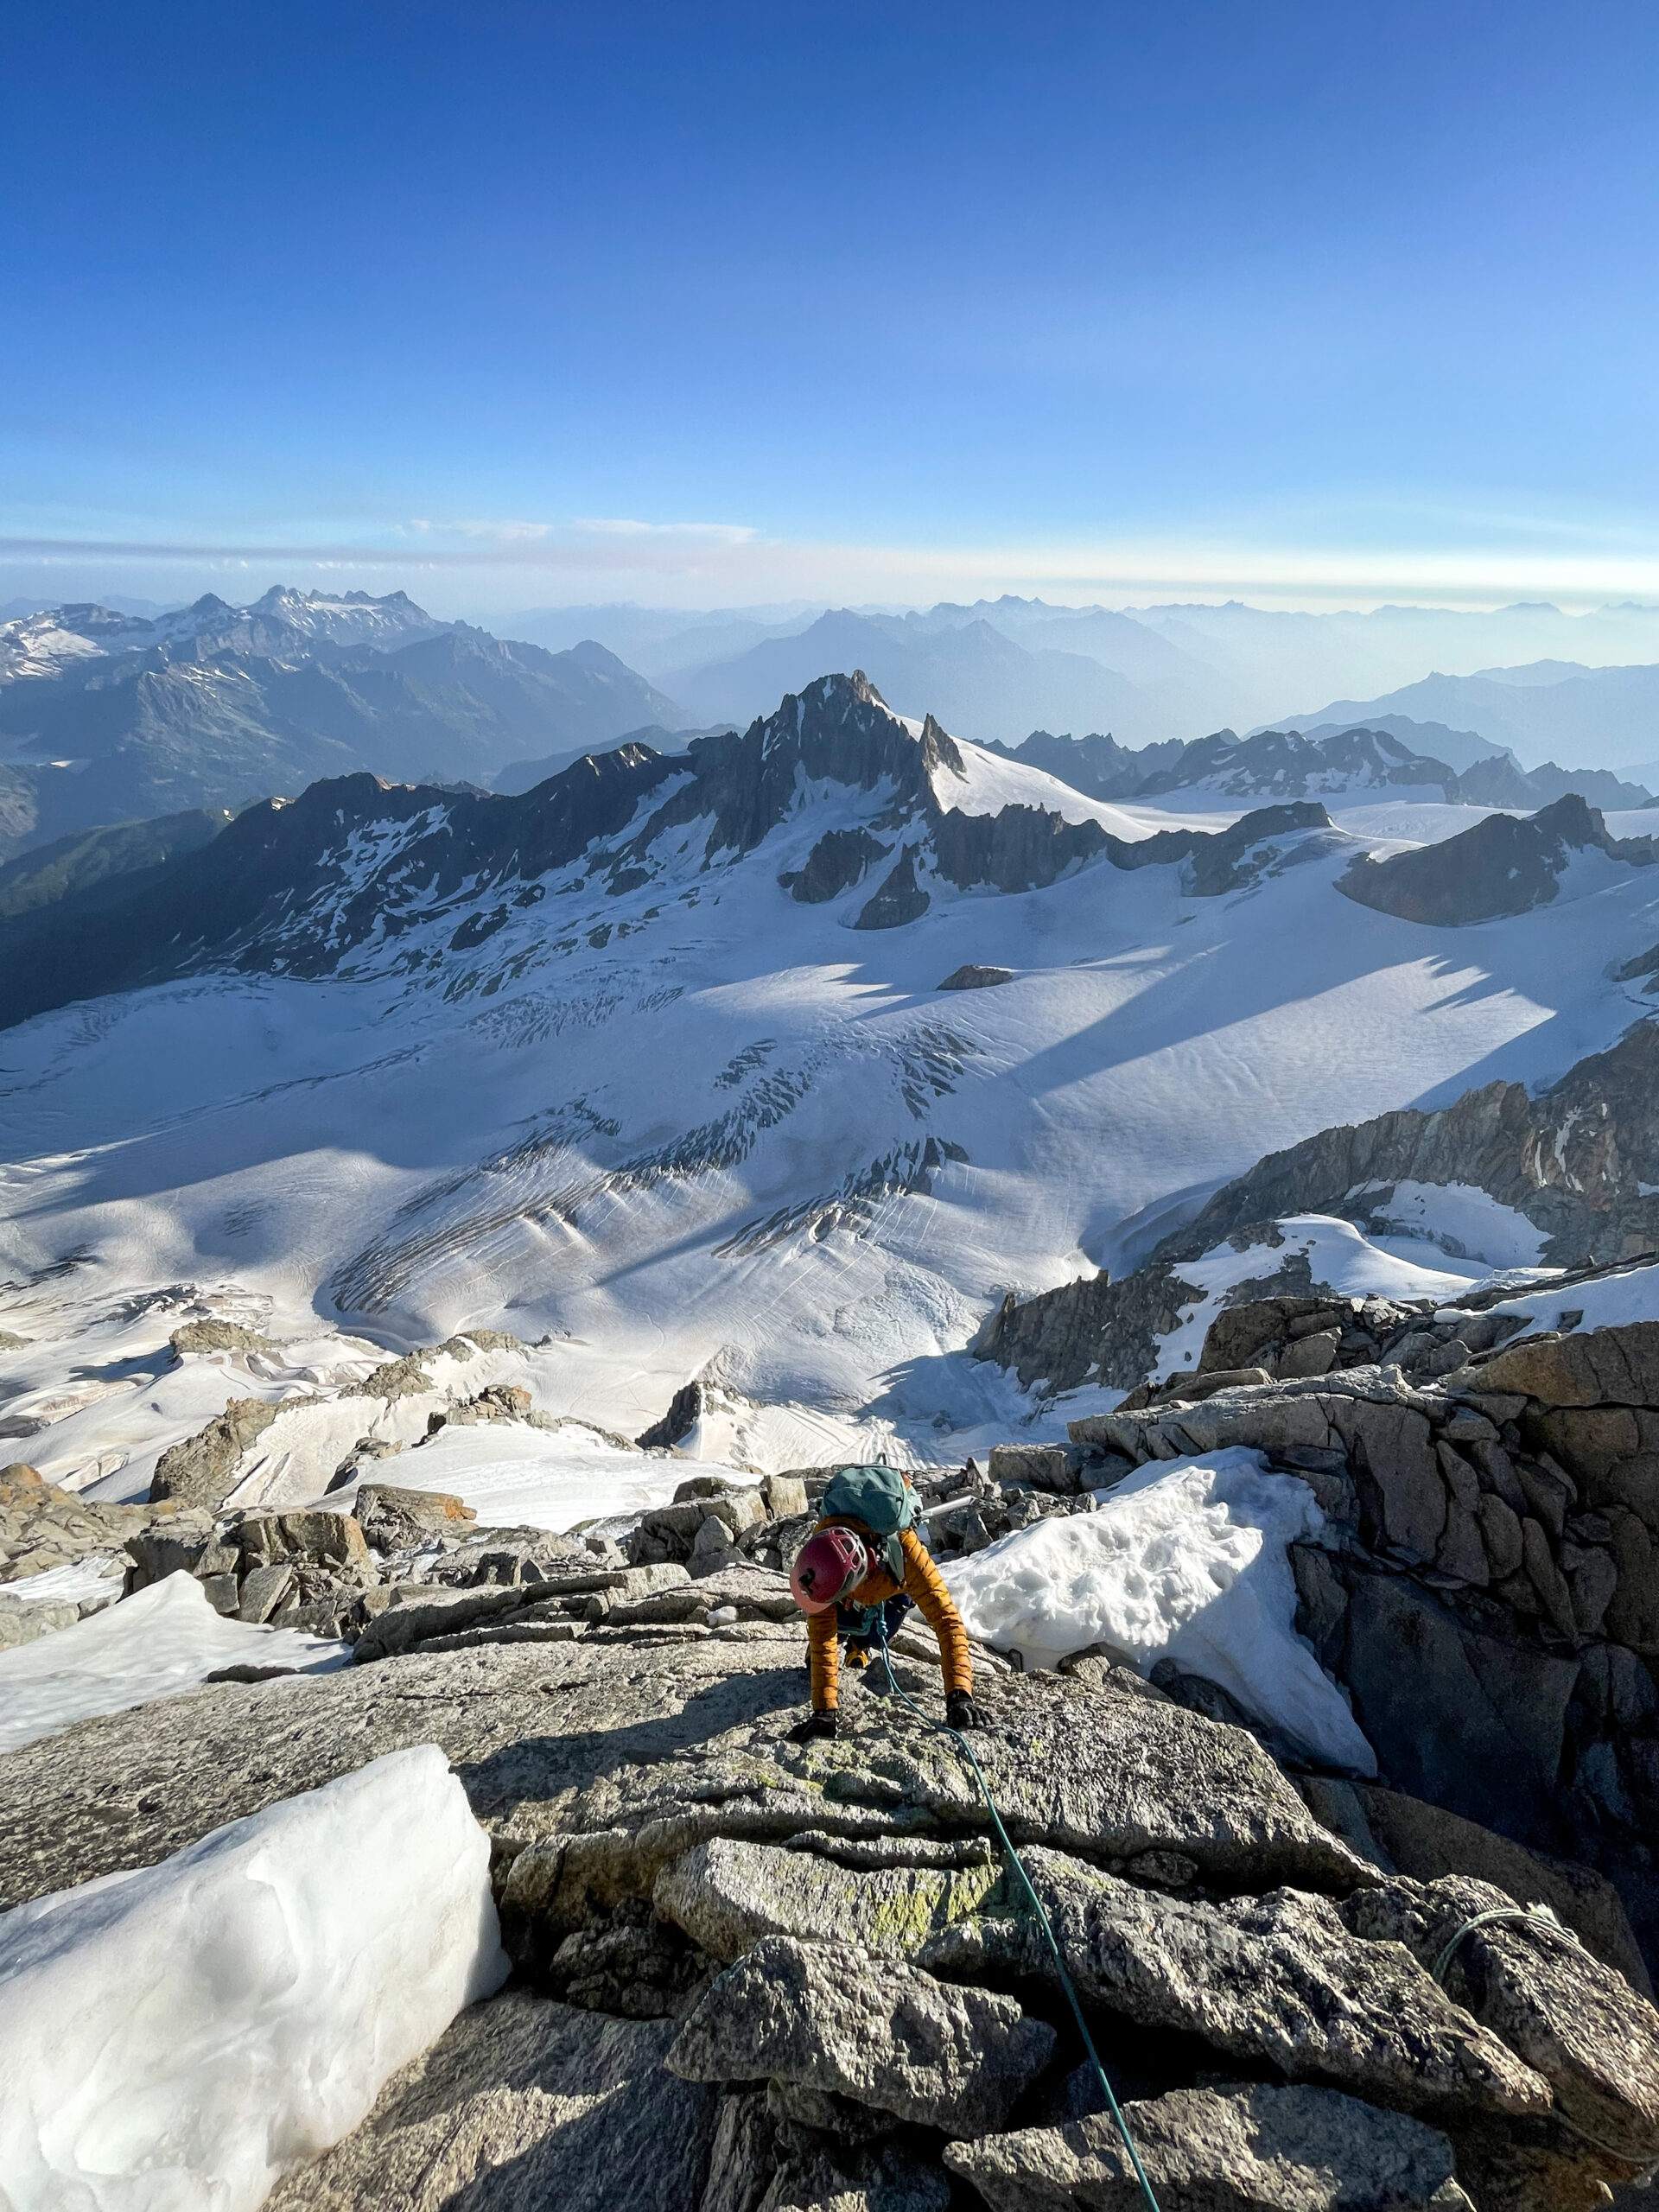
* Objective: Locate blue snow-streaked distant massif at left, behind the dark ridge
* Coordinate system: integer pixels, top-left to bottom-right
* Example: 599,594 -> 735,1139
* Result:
0,588 -> 690,858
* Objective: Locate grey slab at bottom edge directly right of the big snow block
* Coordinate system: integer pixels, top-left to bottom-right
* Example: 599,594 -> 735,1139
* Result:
265,1991 -> 719,2212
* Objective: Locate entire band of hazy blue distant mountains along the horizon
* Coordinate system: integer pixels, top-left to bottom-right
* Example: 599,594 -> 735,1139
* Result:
13,586 -> 1659,861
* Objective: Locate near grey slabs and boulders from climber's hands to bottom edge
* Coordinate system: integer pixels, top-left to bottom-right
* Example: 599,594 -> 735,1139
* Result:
0,1628 -> 1659,2212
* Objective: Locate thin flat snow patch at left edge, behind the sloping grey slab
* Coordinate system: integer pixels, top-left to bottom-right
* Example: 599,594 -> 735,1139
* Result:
0,1571 -> 352,1751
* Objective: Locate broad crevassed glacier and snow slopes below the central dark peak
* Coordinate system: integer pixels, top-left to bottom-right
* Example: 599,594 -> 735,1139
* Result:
0,672 -> 1659,1491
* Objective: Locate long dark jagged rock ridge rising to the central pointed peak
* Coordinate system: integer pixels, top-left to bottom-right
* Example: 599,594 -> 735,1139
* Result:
0,658 -> 1330,1027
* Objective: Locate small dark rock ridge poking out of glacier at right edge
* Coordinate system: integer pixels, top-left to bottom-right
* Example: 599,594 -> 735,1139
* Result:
1336,791 -> 1659,929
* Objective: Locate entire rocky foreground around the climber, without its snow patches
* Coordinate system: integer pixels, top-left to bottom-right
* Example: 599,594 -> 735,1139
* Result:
0,1300 -> 1659,2212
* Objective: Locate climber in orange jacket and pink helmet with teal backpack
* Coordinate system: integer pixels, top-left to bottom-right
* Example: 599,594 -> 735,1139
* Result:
790,1466 -> 980,1743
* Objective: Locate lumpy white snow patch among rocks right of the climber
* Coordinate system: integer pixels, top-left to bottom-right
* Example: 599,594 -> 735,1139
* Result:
940,1446 -> 1376,1774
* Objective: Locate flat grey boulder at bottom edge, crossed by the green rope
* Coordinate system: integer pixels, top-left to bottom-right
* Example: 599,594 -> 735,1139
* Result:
944,2084 -> 1469,2212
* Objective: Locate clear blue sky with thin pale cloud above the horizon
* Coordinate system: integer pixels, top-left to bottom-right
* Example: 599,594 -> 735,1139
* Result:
0,0 -> 1659,613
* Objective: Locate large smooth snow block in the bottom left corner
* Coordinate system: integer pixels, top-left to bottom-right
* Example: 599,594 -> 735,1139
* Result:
0,1743 -> 506,2212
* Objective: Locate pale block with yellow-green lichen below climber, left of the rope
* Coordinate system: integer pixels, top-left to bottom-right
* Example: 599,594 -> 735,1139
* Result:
652,1836 -> 1002,1964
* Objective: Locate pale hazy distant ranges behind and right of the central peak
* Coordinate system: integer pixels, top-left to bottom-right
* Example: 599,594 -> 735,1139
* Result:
513,597 -> 1659,767
